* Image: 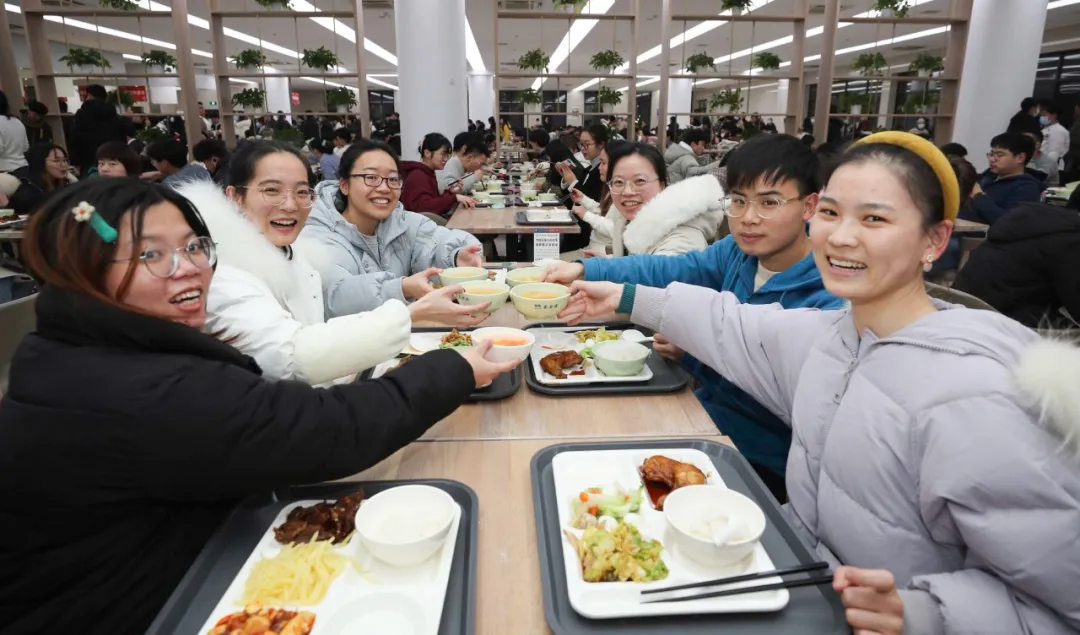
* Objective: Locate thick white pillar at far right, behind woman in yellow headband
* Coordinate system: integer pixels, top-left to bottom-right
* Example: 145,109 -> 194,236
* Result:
951,0 -> 1049,171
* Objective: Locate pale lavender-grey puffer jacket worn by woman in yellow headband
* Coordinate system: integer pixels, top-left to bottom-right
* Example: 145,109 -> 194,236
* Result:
633,284 -> 1080,635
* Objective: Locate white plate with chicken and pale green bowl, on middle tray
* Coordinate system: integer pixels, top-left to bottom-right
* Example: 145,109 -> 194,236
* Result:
529,326 -> 652,386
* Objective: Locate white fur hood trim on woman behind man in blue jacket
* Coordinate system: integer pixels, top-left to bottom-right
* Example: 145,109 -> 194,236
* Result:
616,175 -> 724,254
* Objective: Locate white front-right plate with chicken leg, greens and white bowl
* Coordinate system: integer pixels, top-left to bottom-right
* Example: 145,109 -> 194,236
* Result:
552,448 -> 789,619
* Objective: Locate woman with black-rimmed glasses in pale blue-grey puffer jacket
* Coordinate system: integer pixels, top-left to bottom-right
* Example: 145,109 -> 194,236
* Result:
300,139 -> 484,317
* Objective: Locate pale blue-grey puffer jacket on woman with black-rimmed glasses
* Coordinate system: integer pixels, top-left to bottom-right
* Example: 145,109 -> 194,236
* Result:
300,181 -> 480,319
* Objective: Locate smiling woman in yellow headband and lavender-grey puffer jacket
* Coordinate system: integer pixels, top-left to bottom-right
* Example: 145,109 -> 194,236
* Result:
562,133 -> 1080,635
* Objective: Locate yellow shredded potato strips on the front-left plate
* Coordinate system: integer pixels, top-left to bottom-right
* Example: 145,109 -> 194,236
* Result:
238,540 -> 346,606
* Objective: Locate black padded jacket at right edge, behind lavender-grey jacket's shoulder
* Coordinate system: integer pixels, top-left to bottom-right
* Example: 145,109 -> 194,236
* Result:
953,203 -> 1080,328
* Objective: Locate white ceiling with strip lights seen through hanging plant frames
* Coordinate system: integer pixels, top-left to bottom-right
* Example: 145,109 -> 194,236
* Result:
6,0 -> 1080,94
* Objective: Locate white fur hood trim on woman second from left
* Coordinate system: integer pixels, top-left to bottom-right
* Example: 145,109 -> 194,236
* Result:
176,180 -> 303,306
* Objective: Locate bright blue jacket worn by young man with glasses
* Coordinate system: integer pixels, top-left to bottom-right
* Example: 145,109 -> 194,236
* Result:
583,235 -> 843,475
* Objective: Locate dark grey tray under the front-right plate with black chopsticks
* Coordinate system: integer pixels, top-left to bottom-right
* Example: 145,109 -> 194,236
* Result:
529,440 -> 851,635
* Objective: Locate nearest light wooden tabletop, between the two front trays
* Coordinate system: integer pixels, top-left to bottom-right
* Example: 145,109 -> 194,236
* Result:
347,434 -> 728,635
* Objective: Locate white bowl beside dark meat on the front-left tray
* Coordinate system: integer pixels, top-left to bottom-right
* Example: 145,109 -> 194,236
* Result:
356,485 -> 455,567
